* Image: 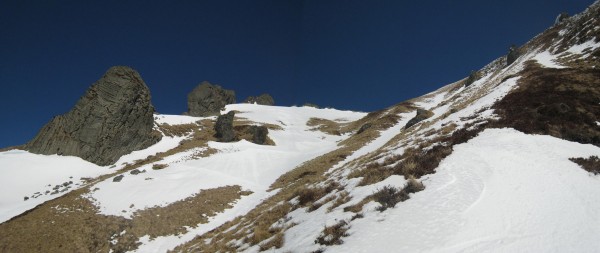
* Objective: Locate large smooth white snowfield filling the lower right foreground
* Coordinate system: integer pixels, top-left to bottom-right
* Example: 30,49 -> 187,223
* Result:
326,129 -> 600,252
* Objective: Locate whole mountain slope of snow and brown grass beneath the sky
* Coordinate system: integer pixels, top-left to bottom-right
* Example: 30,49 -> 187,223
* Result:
0,2 -> 600,252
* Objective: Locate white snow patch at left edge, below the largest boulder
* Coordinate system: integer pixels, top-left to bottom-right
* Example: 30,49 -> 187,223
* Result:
0,150 -> 111,223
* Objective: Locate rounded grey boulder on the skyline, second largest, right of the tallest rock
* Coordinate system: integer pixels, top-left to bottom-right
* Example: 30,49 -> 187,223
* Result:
186,81 -> 235,117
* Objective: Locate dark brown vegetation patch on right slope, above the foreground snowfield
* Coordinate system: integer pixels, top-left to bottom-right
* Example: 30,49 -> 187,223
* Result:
493,63 -> 600,146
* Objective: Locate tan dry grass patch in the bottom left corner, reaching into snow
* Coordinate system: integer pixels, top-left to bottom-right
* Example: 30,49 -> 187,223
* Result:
0,186 -> 247,252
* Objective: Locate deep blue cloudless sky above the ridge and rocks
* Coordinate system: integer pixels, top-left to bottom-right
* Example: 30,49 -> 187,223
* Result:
0,0 -> 593,147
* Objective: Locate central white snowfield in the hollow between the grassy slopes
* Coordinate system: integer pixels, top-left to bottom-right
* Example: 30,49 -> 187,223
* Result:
78,104 -> 366,252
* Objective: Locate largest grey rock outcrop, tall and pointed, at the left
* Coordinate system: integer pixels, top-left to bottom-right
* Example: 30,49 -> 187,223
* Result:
24,66 -> 161,166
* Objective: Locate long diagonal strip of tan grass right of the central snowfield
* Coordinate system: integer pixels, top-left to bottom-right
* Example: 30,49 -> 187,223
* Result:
175,106 -> 407,252
